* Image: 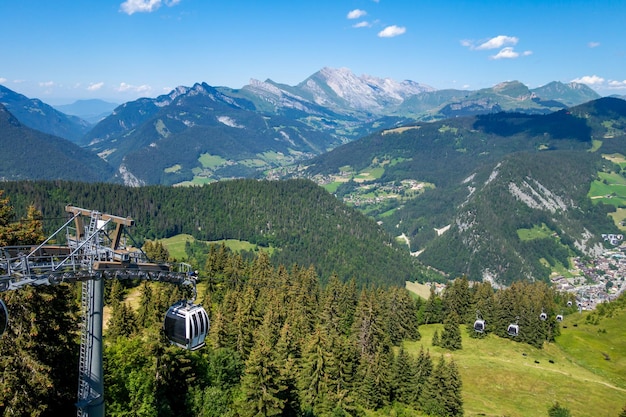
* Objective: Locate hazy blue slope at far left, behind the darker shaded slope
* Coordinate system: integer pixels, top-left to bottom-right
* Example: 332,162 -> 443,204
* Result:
0,85 -> 91,143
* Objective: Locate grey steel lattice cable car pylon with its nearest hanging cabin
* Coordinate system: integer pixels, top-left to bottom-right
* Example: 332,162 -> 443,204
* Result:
0,206 -> 209,417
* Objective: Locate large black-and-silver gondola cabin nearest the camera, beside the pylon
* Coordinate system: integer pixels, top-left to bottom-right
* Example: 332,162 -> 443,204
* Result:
163,301 -> 210,350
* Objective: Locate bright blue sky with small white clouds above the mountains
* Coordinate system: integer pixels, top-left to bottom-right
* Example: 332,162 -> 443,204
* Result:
0,0 -> 626,104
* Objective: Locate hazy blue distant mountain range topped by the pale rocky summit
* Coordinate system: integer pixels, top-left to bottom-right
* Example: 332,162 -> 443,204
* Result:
0,68 -> 599,185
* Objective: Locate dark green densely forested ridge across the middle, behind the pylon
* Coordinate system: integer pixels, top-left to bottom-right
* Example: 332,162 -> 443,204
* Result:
2,180 -> 438,286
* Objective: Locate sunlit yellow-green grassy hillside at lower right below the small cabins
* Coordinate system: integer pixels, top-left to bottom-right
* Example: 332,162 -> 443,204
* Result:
405,310 -> 626,417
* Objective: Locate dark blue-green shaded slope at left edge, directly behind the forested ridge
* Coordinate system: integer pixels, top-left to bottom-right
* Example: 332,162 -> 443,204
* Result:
0,104 -> 114,182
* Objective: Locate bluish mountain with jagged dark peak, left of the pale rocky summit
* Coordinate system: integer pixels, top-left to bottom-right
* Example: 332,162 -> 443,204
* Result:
87,84 -> 352,184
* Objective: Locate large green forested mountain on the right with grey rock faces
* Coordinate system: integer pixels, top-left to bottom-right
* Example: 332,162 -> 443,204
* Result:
292,99 -> 626,282
